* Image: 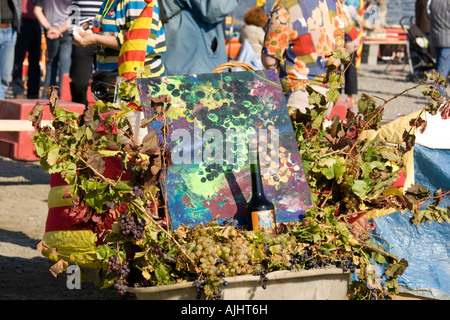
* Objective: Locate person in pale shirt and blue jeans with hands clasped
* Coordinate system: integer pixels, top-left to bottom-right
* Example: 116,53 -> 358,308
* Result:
34,0 -> 72,97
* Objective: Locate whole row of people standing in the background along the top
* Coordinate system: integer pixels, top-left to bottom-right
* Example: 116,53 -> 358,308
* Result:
0,0 -> 450,109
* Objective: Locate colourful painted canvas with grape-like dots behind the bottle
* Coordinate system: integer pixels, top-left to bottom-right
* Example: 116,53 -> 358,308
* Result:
137,70 -> 314,228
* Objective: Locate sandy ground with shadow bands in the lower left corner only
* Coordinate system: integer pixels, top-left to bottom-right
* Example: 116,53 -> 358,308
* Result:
0,157 -> 120,300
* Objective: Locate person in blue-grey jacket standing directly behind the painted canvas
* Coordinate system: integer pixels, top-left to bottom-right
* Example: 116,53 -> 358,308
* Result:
160,0 -> 239,75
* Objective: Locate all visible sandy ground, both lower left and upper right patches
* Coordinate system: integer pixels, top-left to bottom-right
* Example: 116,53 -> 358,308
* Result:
0,64 -> 436,300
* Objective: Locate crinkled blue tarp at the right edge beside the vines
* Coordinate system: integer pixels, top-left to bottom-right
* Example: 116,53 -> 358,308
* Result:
373,144 -> 450,300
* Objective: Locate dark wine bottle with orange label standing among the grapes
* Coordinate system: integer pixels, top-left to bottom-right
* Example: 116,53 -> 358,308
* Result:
247,150 -> 277,235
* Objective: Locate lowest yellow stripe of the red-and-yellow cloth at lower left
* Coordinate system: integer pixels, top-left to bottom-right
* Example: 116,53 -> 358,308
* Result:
42,230 -> 101,269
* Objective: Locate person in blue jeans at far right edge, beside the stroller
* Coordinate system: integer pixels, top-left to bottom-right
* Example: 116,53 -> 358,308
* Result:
429,0 -> 450,95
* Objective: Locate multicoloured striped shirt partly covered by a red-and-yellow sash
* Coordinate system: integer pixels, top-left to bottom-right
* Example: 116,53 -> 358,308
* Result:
96,0 -> 166,76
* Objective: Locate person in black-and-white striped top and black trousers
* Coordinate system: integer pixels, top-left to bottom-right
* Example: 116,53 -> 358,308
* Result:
70,0 -> 103,106
